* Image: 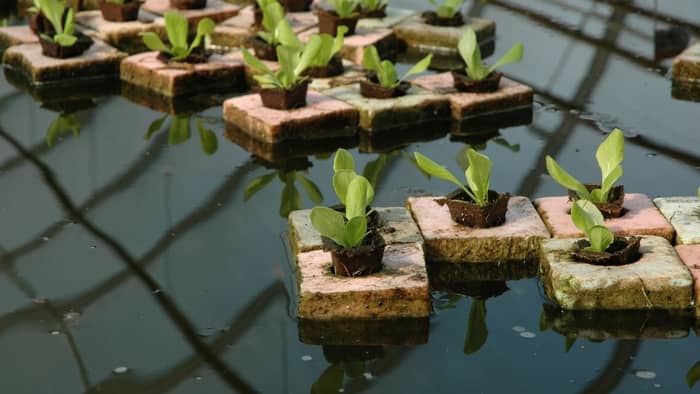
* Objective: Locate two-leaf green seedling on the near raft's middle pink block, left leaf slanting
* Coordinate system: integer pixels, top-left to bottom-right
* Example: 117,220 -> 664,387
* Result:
415,148 -> 491,207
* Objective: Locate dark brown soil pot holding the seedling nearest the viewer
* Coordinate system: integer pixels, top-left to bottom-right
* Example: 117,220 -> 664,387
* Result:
321,231 -> 385,276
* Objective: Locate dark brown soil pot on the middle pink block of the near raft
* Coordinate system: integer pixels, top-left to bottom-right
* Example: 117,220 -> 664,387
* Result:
435,189 -> 510,228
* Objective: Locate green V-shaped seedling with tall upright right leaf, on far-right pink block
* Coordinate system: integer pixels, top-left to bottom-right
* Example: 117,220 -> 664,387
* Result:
546,129 -> 625,203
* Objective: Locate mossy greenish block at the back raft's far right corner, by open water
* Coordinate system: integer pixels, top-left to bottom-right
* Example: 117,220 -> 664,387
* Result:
394,16 -> 496,53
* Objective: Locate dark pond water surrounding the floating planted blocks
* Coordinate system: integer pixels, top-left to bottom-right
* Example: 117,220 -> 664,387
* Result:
0,0 -> 700,393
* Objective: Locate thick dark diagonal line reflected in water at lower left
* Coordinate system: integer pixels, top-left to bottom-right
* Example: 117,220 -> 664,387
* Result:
0,128 -> 255,392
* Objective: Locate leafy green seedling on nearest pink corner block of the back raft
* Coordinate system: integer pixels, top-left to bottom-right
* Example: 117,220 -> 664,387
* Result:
242,36 -> 321,90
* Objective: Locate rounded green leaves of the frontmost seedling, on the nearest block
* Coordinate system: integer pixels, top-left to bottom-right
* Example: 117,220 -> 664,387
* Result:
311,175 -> 374,249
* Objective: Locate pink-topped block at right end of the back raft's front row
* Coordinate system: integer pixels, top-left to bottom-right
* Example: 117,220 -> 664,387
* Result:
411,73 -> 533,121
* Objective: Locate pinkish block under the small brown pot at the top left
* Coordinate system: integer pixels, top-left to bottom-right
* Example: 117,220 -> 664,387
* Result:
75,11 -> 165,53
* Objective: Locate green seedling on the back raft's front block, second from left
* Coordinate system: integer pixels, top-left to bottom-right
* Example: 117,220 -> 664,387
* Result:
140,12 -> 216,60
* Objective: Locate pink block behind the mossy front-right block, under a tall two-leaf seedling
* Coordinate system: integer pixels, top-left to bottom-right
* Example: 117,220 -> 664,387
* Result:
535,193 -> 673,241
